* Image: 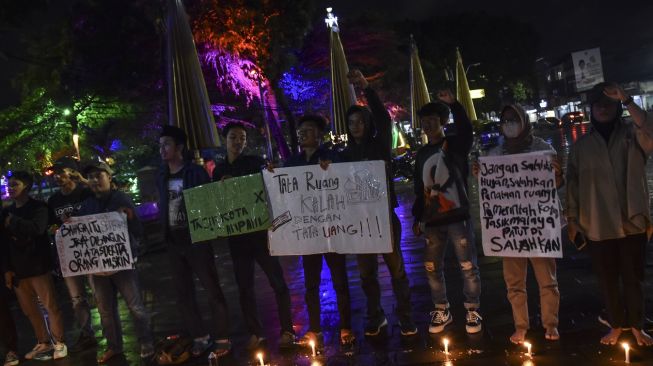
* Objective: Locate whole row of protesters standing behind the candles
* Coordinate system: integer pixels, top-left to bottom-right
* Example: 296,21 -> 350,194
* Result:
0,70 -> 653,366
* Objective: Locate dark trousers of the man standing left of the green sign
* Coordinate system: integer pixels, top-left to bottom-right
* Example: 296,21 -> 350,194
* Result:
168,234 -> 229,339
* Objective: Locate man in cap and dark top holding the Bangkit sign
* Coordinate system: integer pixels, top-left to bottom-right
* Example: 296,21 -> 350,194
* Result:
73,161 -> 154,363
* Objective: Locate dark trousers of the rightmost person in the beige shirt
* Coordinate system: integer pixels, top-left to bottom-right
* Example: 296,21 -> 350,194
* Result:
589,234 -> 648,329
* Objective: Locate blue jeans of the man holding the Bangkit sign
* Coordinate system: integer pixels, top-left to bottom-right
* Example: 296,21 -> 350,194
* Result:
91,269 -> 153,352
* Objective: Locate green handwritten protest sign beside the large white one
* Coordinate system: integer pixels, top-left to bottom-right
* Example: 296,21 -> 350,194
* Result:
184,173 -> 270,243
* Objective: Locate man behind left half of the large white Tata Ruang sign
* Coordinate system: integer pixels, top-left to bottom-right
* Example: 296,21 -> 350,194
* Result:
283,115 -> 355,347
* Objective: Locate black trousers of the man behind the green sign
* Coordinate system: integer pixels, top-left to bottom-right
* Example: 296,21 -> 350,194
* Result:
229,231 -> 295,337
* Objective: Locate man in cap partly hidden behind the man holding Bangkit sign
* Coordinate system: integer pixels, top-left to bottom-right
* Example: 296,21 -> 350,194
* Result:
48,157 -> 97,352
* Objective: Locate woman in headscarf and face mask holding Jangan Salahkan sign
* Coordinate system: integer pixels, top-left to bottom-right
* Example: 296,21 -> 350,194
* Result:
472,104 -> 564,344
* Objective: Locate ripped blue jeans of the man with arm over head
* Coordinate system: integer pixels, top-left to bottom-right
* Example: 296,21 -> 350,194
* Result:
422,220 -> 481,309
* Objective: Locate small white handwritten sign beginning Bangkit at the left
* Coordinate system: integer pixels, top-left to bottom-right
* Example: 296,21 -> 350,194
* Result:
55,211 -> 133,277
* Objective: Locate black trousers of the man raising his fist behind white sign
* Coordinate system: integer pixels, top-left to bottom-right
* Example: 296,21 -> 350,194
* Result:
356,212 -> 411,321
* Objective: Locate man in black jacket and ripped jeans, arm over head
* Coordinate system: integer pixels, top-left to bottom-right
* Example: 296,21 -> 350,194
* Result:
412,90 -> 482,333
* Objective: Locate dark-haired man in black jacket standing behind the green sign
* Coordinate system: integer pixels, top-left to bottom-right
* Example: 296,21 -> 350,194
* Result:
213,123 -> 295,351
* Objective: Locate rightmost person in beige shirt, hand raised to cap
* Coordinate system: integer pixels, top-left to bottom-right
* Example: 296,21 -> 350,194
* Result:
565,83 -> 653,346
